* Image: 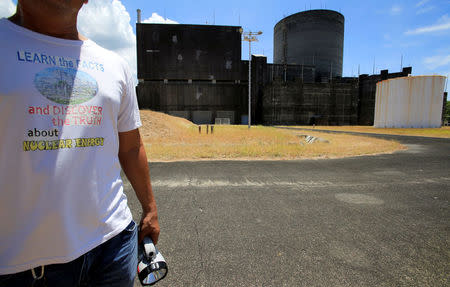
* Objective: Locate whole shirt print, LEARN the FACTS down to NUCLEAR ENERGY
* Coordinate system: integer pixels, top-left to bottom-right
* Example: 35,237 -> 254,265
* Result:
17,51 -> 105,152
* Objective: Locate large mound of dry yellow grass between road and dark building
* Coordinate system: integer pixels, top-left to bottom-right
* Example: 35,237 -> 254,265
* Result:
141,110 -> 404,161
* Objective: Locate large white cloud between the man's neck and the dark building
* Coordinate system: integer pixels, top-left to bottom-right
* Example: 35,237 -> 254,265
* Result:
78,0 -> 137,80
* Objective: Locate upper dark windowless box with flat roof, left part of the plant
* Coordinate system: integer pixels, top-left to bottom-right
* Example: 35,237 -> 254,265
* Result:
136,24 -> 241,81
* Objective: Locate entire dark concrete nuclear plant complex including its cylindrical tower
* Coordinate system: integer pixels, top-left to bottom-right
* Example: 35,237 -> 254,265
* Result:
136,10 -> 426,125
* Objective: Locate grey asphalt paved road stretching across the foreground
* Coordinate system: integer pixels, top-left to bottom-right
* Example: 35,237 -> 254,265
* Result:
126,133 -> 450,287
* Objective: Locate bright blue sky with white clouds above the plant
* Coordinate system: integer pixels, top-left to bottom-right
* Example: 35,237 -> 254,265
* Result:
0,0 -> 450,90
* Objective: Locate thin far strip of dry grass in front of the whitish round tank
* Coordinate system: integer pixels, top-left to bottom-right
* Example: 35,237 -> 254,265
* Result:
292,126 -> 450,138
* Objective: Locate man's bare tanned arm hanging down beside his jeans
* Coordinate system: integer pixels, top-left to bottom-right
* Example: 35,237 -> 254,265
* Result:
119,129 -> 159,244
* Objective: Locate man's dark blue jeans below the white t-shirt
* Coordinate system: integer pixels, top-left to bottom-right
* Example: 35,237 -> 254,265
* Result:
0,221 -> 138,287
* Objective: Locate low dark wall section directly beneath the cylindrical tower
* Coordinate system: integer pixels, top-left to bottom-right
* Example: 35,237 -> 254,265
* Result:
263,79 -> 358,125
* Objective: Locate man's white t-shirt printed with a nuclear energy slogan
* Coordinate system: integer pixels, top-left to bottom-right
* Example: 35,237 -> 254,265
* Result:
0,19 -> 141,274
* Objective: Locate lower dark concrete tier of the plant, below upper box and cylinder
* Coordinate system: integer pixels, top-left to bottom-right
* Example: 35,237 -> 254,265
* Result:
137,67 -> 411,125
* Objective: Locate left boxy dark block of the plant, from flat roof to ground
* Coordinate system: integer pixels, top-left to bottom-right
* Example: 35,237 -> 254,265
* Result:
136,23 -> 246,124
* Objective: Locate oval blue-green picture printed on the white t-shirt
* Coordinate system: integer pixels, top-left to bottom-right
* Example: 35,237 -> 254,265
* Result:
34,67 -> 98,105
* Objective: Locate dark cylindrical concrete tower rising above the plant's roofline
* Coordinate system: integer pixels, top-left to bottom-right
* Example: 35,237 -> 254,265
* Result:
273,10 -> 345,77
